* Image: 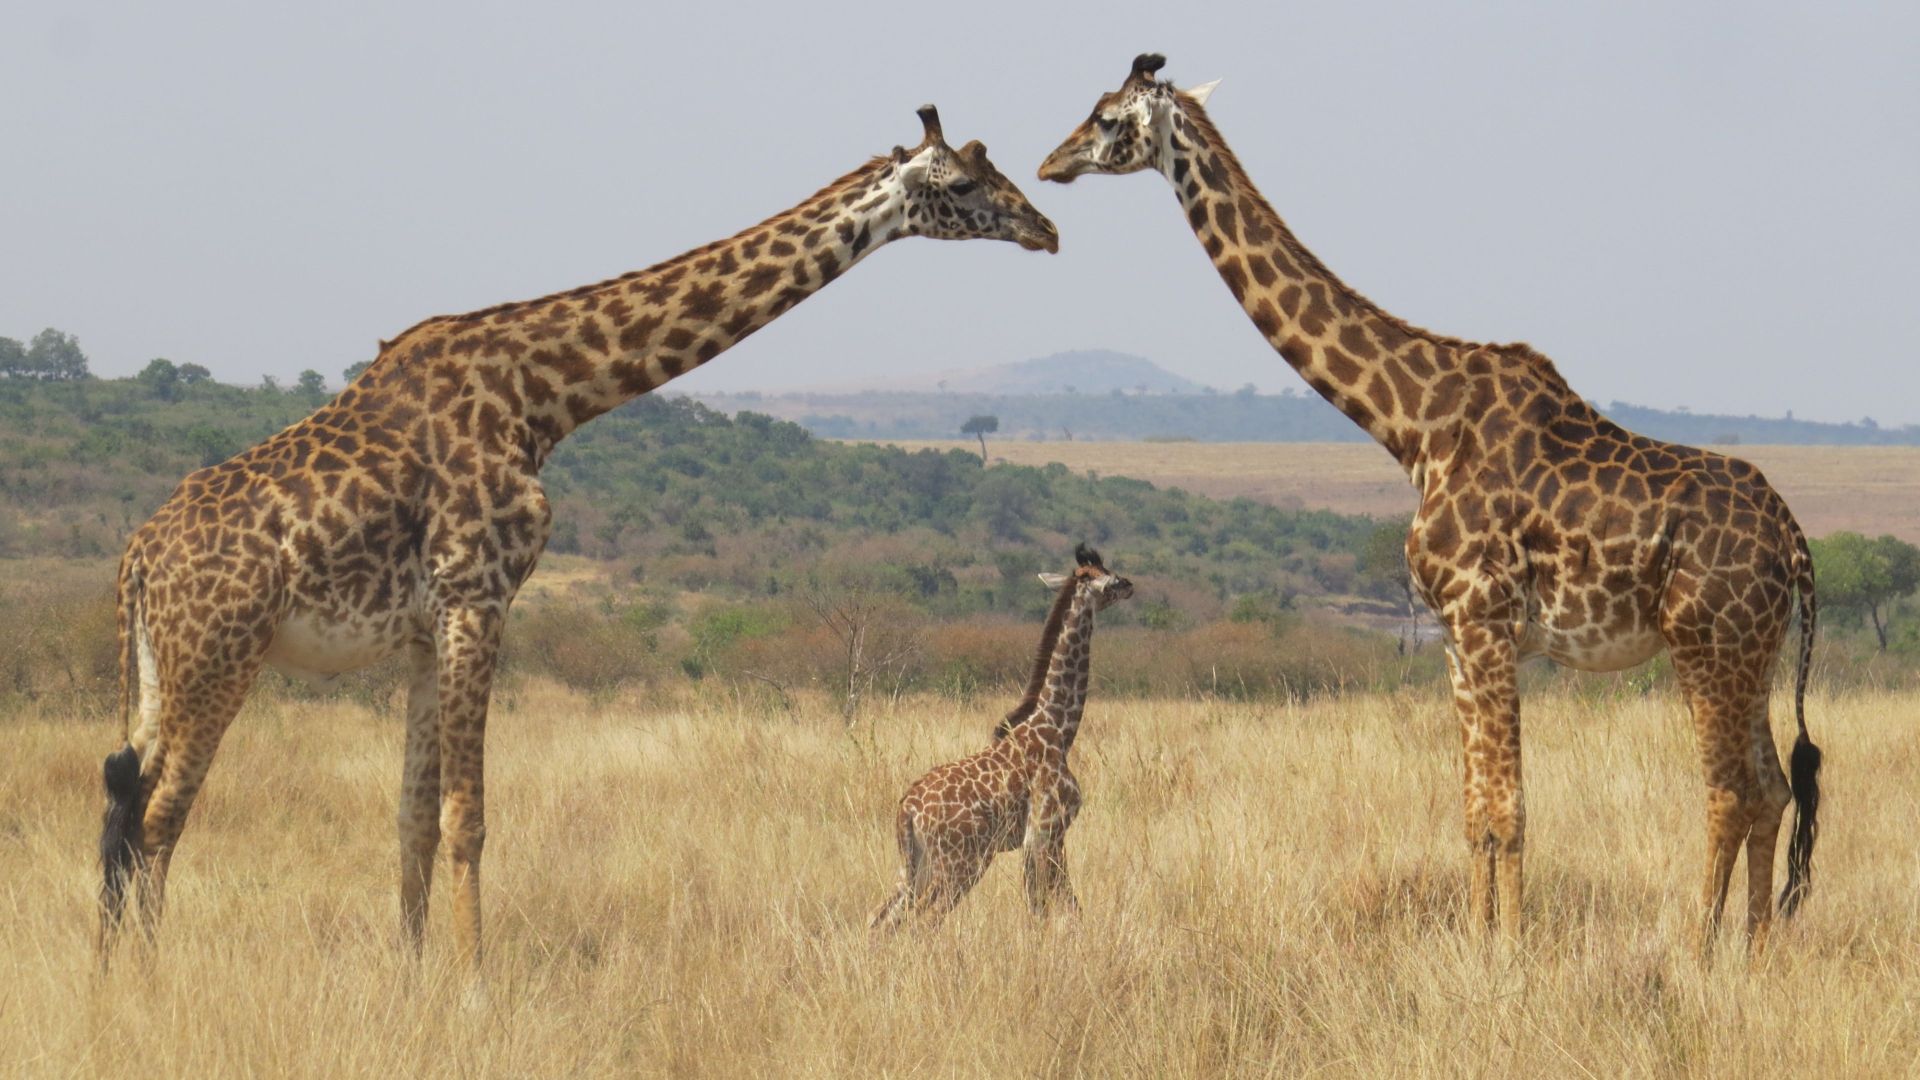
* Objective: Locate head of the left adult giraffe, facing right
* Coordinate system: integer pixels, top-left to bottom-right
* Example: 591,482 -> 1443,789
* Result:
893,106 -> 1060,252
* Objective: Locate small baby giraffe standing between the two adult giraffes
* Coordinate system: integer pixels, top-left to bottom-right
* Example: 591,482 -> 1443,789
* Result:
868,544 -> 1133,928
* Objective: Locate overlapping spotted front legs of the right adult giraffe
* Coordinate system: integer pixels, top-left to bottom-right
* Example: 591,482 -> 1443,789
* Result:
1448,625 -> 1526,940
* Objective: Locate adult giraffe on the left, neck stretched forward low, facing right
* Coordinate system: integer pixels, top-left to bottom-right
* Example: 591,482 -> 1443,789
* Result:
100,106 -> 1060,961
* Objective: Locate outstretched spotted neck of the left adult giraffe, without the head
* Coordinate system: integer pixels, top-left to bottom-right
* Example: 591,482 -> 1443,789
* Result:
384,149 -> 918,461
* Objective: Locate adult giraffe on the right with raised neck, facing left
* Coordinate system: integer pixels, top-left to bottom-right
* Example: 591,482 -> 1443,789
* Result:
1041,54 -> 1820,951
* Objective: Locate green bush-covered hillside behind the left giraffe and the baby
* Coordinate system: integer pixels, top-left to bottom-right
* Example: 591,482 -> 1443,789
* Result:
0,379 -> 1373,617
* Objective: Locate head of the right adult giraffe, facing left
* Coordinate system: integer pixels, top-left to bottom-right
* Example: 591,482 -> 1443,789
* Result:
1041,52 -> 1217,184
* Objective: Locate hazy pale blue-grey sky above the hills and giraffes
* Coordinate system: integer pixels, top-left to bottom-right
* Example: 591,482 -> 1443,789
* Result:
0,0 -> 1920,423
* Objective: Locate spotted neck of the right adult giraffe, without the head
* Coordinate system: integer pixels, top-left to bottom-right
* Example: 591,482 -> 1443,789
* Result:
1160,102 -> 1473,477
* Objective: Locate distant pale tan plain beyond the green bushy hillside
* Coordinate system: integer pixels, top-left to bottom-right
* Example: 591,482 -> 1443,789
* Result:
879,440 -> 1920,544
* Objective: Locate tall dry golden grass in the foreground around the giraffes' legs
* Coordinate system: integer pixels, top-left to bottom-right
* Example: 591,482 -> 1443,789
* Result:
0,684 -> 1920,1076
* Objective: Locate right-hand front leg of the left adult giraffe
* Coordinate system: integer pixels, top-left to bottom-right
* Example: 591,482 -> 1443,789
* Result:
436,607 -> 505,967
